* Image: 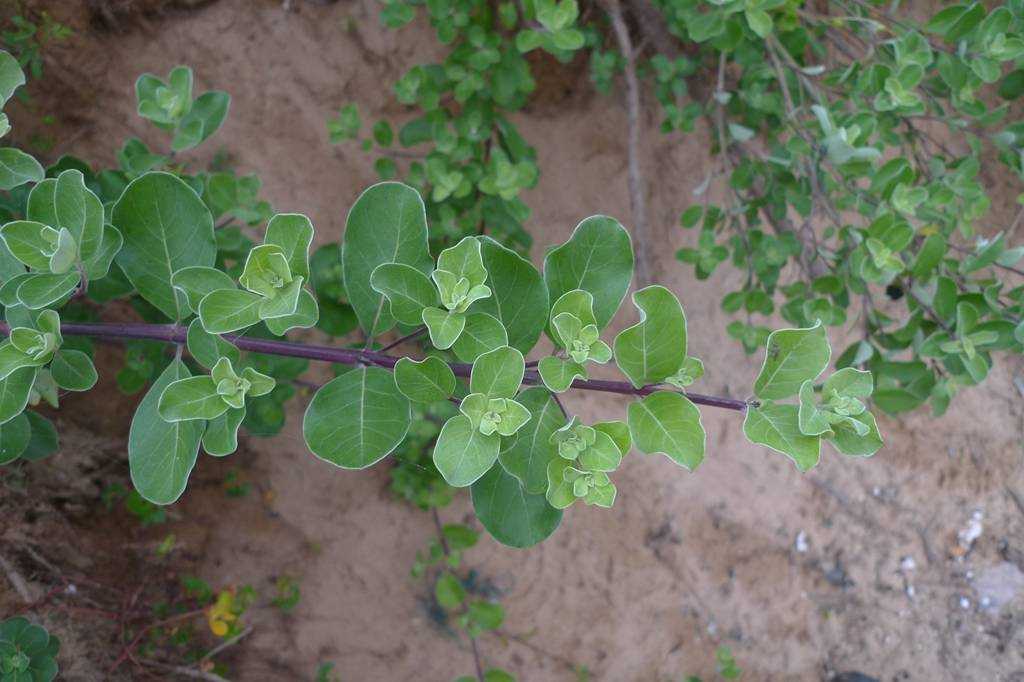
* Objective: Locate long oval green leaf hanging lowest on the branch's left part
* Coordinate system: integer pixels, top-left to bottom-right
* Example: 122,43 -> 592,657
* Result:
128,360 -> 203,505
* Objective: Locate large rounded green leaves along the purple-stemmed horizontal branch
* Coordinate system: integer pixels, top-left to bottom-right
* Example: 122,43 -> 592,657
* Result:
0,54 -> 880,552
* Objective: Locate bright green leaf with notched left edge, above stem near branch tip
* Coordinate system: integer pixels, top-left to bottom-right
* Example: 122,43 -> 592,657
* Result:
615,285 -> 686,388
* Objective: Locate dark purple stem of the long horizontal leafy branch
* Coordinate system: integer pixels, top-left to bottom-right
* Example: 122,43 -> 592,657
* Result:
0,323 -> 758,412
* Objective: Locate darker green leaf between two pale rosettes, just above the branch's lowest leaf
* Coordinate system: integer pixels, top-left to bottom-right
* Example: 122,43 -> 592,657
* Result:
498,386 -> 565,495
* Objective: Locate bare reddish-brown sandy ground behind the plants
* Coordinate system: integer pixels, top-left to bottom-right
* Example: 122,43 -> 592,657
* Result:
0,0 -> 1024,682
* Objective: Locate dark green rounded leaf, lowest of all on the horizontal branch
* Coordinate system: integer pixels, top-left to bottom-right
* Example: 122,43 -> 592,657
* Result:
471,458 -> 562,547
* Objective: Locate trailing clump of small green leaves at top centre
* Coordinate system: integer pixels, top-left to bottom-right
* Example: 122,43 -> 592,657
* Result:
328,0 -> 587,251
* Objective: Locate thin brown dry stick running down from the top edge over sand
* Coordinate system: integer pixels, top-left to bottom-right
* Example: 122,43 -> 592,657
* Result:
603,0 -> 651,289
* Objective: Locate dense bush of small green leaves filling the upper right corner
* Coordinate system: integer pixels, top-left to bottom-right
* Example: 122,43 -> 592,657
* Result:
630,0 -> 1024,415
